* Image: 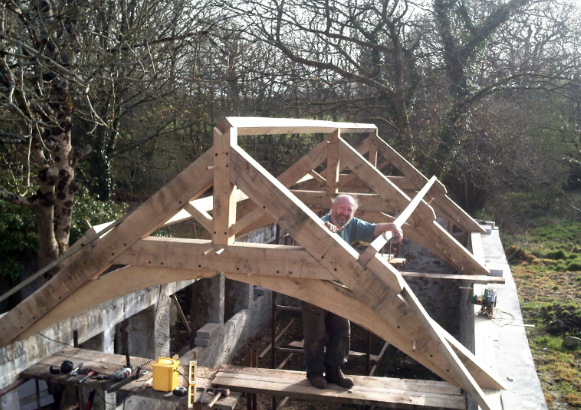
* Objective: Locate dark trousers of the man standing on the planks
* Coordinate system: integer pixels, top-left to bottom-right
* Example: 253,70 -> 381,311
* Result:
301,301 -> 350,377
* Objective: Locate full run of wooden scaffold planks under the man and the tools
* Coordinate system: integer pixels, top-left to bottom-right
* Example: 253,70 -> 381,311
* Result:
22,347 -> 466,410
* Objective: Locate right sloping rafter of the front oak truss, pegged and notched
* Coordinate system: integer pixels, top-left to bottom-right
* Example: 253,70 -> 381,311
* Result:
231,147 -> 494,398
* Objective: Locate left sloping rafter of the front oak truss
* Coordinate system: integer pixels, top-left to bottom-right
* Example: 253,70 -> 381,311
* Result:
0,151 -> 212,346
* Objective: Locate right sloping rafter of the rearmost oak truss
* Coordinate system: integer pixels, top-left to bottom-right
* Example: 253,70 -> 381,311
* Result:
376,137 -> 484,233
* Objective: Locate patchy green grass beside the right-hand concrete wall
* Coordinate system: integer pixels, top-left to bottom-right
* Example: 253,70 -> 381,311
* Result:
503,220 -> 581,409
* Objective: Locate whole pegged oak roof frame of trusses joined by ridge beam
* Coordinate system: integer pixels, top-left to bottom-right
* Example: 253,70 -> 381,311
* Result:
0,117 -> 503,409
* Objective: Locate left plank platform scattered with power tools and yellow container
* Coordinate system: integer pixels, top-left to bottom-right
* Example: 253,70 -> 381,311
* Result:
22,347 -> 242,410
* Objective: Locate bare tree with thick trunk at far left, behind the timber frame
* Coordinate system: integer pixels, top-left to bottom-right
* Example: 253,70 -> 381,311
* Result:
0,0 -> 218,278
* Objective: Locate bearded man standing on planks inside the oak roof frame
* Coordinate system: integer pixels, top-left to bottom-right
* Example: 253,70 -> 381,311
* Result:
301,195 -> 403,389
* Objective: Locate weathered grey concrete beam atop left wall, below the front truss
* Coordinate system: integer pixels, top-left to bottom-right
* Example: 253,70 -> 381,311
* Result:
0,281 -> 193,388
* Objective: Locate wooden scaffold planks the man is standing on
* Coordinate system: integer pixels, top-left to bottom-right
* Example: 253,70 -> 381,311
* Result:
213,365 -> 466,410
